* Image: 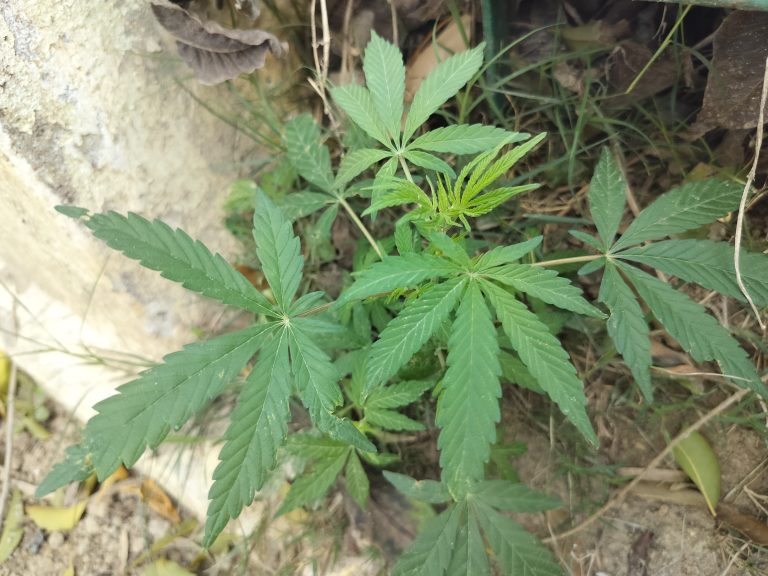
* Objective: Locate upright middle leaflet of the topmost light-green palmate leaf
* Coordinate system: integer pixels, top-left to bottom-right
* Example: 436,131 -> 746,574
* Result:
363,32 -> 405,142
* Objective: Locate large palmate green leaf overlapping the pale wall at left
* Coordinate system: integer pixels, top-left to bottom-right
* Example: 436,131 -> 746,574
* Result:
37,193 -> 376,545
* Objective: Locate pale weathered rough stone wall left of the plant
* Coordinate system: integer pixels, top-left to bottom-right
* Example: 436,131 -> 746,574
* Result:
0,0 -> 248,532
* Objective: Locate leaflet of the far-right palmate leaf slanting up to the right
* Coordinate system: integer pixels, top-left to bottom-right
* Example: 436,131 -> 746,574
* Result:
611,178 -> 742,252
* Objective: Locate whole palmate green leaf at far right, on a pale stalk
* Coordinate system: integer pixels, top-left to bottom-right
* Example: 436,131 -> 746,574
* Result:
571,149 -> 768,401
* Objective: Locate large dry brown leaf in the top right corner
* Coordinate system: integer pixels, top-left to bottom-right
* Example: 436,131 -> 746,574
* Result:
691,11 -> 768,137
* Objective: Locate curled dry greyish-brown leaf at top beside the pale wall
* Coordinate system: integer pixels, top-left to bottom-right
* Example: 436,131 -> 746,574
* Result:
152,3 -> 288,85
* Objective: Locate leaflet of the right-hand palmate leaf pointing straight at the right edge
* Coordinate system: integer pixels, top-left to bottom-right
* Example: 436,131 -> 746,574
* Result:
616,240 -> 768,307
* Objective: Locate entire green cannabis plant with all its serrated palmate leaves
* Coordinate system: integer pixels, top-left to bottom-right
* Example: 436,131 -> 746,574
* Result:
38,34 -> 768,576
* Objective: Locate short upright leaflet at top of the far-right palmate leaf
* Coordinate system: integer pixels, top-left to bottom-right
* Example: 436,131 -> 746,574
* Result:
588,147 -> 627,250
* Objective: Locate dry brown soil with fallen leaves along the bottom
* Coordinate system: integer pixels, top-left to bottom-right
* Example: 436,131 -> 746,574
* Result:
0,376 -> 768,576
